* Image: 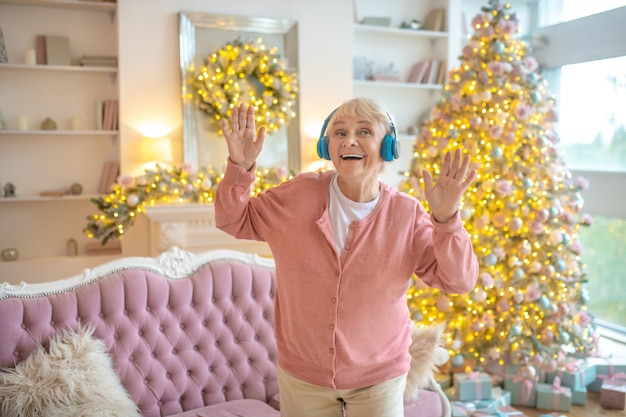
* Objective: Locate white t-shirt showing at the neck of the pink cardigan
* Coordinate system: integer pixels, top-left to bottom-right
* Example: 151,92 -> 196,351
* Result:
328,174 -> 380,254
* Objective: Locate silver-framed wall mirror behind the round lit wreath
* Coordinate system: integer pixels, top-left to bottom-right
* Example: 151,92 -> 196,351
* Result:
179,12 -> 300,173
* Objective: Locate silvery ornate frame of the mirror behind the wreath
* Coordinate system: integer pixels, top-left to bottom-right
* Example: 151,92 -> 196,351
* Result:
179,12 -> 300,173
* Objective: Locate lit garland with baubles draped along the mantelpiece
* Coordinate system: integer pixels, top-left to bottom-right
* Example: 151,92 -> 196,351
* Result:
83,165 -> 293,245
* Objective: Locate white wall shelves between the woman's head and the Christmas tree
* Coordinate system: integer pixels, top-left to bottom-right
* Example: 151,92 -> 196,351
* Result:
352,0 -> 461,186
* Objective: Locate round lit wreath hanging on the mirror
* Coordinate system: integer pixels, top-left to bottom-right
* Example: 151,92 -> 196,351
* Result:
194,39 -> 298,133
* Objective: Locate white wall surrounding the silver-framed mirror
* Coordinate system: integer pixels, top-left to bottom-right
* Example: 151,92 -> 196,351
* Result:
117,0 -> 353,255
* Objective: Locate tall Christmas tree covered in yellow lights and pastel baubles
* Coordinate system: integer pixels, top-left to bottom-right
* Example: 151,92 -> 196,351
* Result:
400,0 -> 595,370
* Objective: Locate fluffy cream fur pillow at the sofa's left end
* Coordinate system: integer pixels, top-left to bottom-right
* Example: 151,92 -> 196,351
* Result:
0,329 -> 140,417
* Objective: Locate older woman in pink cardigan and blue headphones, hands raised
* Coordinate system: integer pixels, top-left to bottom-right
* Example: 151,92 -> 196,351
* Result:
215,98 -> 478,417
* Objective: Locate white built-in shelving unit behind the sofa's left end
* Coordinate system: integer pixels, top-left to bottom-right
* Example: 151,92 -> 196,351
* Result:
0,0 -> 120,282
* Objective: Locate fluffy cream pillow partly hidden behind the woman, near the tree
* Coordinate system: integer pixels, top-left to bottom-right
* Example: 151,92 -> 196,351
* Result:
404,323 -> 449,400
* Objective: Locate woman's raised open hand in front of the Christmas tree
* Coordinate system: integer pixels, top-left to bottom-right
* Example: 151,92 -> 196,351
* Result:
422,149 -> 476,223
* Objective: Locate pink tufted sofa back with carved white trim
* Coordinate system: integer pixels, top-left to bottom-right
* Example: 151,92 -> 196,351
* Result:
0,248 -> 278,416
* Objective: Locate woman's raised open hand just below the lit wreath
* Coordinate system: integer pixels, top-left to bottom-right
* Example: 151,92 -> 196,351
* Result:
221,103 -> 265,171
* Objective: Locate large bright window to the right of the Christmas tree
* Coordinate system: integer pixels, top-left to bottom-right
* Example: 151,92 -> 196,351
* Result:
530,0 -> 626,334
